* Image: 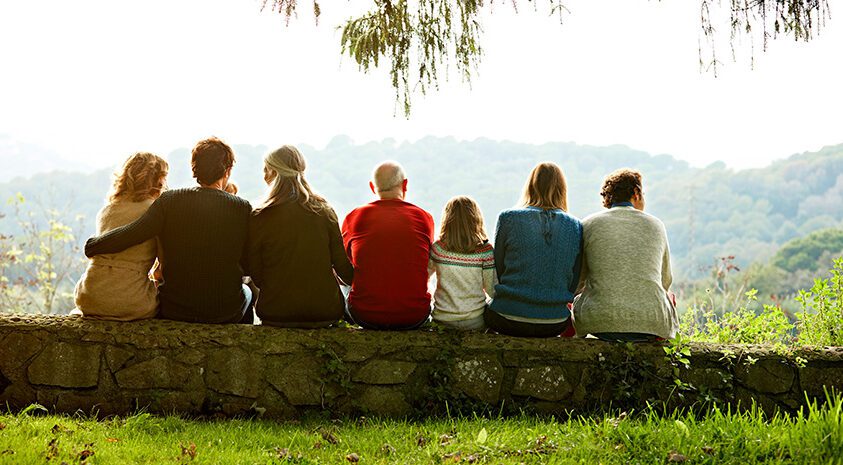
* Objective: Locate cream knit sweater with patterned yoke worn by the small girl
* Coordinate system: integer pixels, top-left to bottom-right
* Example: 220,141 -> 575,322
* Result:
428,241 -> 497,326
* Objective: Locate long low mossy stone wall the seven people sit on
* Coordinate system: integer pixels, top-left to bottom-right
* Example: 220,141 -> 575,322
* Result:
0,314 -> 843,418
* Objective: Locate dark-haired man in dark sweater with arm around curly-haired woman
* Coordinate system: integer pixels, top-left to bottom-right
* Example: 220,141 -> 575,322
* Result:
85,138 -> 254,323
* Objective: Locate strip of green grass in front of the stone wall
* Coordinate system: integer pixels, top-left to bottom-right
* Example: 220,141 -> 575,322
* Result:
0,396 -> 843,465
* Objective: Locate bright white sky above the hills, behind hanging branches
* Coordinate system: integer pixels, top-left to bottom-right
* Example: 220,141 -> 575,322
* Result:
0,0 -> 843,168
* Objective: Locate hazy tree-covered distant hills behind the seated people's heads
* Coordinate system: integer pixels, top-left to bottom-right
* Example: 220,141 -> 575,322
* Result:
0,136 -> 843,280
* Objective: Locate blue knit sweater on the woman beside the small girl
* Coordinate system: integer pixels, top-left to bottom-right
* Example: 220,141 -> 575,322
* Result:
490,207 -> 582,320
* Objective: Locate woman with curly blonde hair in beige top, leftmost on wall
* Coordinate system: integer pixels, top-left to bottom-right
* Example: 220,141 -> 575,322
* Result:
76,152 -> 169,321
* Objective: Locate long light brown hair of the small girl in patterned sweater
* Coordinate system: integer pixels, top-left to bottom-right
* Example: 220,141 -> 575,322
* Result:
439,195 -> 489,253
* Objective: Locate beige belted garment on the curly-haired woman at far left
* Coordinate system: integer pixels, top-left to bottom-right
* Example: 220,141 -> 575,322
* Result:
76,199 -> 158,321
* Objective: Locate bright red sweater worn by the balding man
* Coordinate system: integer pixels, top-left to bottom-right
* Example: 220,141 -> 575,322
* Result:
342,199 -> 433,326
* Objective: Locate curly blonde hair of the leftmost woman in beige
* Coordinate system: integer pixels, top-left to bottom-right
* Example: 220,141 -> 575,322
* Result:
108,152 -> 170,203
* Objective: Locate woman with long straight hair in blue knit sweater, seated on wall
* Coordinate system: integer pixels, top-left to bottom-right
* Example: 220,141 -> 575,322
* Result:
483,162 -> 582,337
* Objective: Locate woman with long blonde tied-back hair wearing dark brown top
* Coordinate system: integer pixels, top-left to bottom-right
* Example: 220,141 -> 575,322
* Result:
248,145 -> 354,328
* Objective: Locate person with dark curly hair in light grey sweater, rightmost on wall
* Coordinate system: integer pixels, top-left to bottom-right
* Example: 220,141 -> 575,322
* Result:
574,169 -> 679,341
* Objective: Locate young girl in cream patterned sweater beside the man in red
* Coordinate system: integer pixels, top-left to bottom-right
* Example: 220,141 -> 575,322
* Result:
428,196 -> 497,330
